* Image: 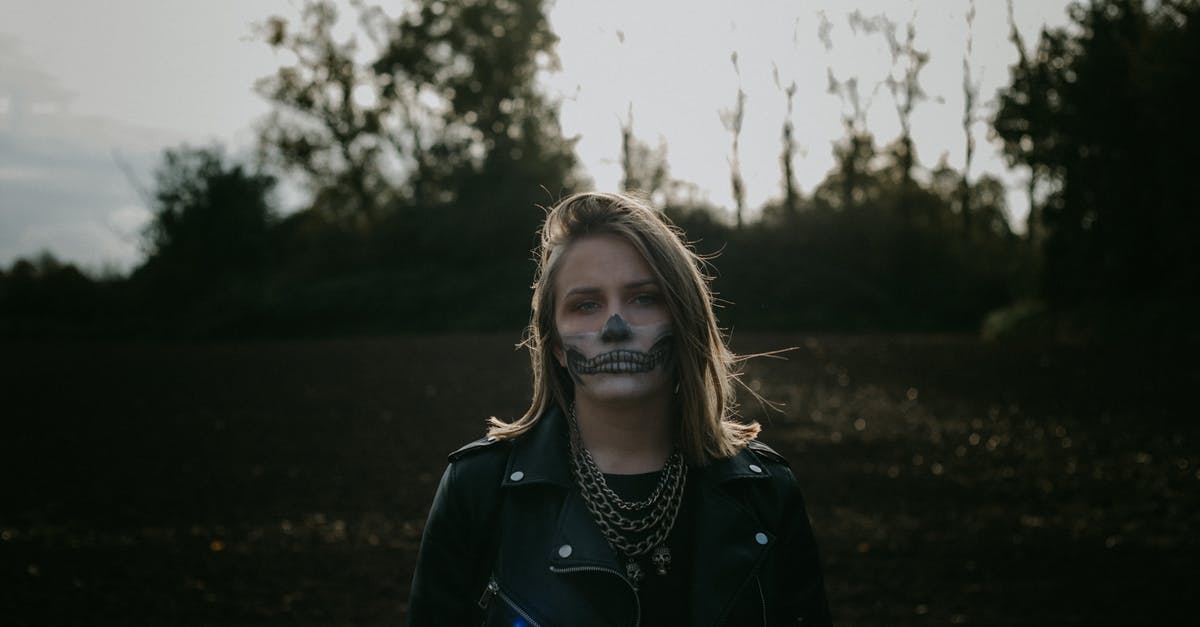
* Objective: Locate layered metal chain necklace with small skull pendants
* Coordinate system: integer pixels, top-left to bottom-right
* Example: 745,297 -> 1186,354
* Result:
570,402 -> 688,590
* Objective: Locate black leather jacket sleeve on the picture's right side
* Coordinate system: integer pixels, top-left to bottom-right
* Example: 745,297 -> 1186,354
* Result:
770,470 -> 833,627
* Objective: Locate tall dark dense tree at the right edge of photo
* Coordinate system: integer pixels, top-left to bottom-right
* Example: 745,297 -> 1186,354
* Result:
995,0 -> 1200,306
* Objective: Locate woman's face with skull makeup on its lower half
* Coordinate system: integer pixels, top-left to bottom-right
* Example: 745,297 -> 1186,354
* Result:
553,234 -> 674,402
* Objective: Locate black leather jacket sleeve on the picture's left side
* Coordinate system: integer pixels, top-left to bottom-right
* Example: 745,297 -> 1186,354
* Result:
408,460 -> 491,627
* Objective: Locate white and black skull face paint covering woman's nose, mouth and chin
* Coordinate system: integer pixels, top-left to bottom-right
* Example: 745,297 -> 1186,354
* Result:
562,315 -> 674,400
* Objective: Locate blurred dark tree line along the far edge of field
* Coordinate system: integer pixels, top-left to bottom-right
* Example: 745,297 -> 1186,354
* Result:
0,0 -> 1200,336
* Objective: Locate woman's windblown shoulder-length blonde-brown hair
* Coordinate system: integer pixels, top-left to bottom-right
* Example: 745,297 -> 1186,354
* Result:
488,192 -> 760,466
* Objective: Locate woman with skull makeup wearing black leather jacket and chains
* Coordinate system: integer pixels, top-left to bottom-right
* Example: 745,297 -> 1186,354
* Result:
409,193 -> 829,627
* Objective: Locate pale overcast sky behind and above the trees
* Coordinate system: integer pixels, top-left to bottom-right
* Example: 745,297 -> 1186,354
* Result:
0,0 -> 1068,271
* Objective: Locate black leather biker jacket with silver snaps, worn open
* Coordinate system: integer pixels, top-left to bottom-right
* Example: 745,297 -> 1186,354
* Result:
408,410 -> 830,627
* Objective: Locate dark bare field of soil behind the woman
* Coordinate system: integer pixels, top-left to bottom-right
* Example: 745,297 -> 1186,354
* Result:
0,334 -> 1200,626
